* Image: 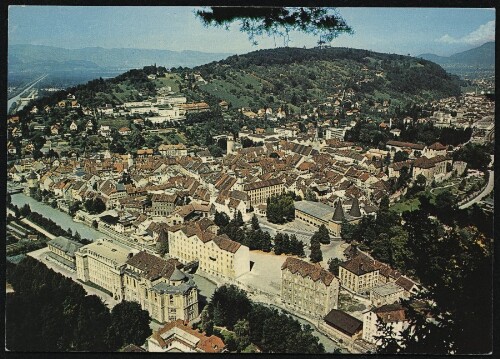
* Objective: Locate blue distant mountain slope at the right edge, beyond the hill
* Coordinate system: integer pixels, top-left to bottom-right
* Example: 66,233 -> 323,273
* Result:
417,41 -> 495,74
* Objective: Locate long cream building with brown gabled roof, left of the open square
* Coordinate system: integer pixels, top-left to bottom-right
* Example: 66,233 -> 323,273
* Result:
168,220 -> 250,279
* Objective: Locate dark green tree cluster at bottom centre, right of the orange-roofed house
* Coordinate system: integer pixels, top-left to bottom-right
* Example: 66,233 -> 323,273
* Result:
200,285 -> 325,354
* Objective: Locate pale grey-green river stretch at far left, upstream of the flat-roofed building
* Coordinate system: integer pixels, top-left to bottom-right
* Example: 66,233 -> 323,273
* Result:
11,193 -> 105,240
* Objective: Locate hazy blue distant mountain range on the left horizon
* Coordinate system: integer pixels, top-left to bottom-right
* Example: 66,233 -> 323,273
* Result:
8,45 -> 232,73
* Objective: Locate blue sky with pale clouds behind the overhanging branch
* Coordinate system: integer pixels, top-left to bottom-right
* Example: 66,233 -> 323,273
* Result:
8,5 -> 496,56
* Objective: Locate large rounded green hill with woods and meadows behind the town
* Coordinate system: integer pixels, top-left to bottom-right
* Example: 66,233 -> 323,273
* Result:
183,48 -> 460,111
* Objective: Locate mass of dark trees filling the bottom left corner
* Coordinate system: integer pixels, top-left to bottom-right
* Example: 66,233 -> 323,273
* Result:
5,257 -> 151,352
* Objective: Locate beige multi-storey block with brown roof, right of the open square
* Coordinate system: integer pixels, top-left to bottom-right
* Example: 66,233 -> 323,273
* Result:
281,257 -> 339,317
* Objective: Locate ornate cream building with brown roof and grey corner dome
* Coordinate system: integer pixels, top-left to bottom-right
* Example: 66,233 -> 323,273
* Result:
122,251 -> 199,323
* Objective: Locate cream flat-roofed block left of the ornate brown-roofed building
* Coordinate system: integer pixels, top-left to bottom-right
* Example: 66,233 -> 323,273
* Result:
75,239 -> 138,301
